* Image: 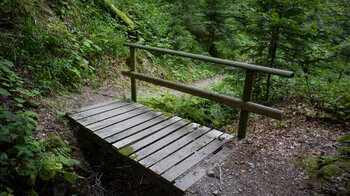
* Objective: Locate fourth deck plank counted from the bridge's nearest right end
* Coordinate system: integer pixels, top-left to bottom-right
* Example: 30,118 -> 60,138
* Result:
136,127 -> 210,167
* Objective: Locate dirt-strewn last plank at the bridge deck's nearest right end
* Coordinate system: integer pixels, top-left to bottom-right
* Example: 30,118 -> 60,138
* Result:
174,147 -> 230,191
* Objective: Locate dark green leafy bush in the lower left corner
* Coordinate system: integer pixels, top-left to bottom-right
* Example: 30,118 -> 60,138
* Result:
0,108 -> 79,194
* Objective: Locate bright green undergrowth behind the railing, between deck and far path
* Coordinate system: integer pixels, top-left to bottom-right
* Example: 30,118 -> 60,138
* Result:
140,76 -> 242,128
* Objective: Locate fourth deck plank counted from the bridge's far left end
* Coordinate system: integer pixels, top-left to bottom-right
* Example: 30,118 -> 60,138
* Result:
86,107 -> 151,131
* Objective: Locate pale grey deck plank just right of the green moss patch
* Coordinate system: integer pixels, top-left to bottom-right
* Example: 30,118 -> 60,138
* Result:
134,123 -> 200,165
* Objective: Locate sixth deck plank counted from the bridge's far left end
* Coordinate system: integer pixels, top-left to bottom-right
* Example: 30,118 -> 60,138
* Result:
105,116 -> 168,143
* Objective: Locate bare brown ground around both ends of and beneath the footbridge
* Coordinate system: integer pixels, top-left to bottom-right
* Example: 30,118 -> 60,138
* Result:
36,76 -> 350,195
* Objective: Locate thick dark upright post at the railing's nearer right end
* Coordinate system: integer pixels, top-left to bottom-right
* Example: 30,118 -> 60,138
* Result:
237,70 -> 255,139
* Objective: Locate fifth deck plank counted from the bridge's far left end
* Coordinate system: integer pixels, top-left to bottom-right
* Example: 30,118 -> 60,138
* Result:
95,111 -> 162,138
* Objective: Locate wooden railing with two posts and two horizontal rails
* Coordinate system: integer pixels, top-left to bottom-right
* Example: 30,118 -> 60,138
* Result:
122,43 -> 294,138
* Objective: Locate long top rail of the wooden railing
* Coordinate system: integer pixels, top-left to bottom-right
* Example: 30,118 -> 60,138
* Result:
124,43 -> 294,78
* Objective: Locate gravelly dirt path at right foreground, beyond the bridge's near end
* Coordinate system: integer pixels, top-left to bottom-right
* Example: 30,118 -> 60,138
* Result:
186,104 -> 350,196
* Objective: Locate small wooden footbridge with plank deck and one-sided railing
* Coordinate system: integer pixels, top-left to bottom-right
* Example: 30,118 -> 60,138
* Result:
69,43 -> 293,192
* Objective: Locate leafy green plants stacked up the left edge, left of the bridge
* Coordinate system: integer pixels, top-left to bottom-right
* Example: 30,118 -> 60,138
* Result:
0,58 -> 78,193
